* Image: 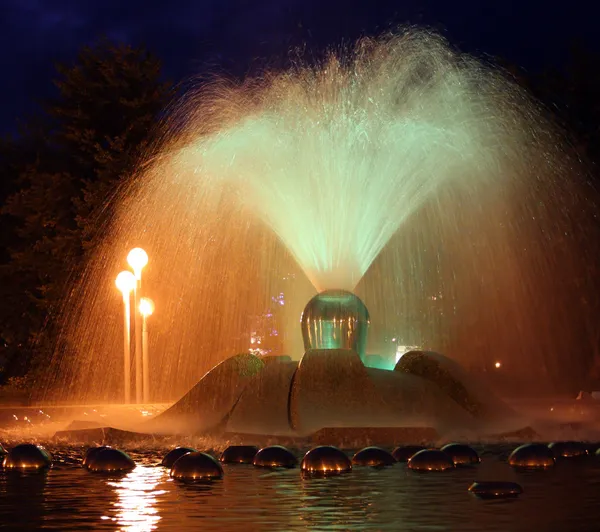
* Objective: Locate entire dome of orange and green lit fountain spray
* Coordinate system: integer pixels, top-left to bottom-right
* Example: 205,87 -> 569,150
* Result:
47,29 -> 593,401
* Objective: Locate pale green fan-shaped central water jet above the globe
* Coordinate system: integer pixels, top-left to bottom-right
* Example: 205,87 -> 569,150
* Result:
171,32 -> 518,291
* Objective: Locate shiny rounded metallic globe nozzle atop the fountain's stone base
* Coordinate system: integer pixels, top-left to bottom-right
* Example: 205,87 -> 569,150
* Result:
300,290 -> 370,361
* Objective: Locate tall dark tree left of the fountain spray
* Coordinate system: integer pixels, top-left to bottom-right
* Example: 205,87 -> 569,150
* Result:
0,41 -> 172,382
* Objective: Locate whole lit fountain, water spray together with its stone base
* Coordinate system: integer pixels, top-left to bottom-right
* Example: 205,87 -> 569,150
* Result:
37,29 -> 587,443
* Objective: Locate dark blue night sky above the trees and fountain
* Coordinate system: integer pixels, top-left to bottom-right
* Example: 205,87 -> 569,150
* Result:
0,0 -> 600,133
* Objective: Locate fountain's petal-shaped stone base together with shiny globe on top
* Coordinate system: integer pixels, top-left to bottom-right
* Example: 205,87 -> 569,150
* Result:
149,290 -> 523,440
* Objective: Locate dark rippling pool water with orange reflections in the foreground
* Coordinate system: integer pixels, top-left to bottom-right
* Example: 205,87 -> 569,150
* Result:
0,448 -> 600,532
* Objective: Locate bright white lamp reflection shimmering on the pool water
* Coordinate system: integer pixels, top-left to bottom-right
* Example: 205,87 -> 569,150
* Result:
102,466 -> 168,532
